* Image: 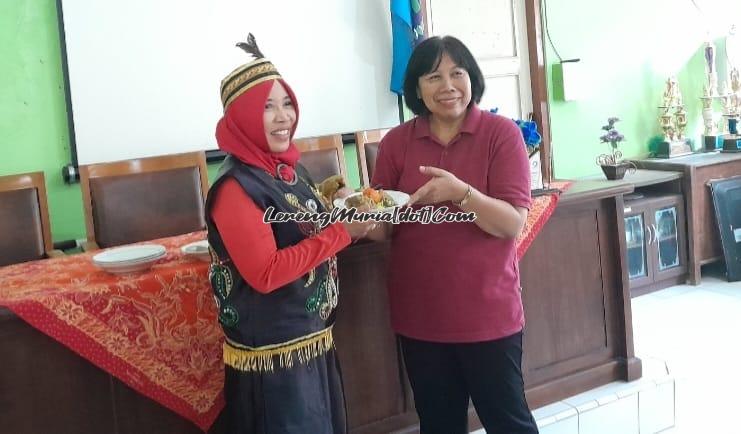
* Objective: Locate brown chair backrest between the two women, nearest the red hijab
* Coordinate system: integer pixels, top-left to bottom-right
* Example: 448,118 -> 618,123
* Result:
295,134 -> 347,184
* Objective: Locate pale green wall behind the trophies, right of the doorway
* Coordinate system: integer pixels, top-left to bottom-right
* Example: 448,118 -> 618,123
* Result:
545,0 -> 732,178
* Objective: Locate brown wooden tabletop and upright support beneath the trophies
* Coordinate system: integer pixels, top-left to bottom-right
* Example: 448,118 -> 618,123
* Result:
634,152 -> 741,285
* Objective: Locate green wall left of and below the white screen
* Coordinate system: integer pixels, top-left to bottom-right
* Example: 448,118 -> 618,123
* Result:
0,0 -> 358,241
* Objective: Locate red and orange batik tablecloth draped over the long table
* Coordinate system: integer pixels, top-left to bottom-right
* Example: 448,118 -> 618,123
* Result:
0,183 -> 569,431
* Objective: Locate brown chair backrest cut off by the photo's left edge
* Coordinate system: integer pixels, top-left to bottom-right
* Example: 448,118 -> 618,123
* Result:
0,172 -> 53,266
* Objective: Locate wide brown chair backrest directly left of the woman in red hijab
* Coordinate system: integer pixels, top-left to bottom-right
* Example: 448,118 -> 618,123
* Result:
80,152 -> 208,247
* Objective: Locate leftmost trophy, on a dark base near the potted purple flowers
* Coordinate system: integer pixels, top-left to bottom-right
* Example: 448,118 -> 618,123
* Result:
656,77 -> 692,158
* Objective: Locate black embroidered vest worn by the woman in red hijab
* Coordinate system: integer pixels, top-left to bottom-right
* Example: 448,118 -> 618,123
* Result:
206,156 -> 338,352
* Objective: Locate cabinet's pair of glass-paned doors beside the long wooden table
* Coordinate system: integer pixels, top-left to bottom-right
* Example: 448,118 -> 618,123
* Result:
624,194 -> 687,296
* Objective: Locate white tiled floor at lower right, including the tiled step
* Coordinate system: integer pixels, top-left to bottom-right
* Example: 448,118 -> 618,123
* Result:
474,267 -> 741,434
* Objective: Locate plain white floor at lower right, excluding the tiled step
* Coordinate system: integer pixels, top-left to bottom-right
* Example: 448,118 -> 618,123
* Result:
632,267 -> 741,434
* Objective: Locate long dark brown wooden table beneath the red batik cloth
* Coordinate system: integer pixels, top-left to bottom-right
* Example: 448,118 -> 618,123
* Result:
0,181 -> 641,434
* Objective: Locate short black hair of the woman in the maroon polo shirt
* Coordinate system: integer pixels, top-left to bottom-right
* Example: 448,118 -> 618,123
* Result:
404,36 -> 486,115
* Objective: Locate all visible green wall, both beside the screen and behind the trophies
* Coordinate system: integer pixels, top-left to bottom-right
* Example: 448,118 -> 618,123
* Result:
0,0 -> 736,244
